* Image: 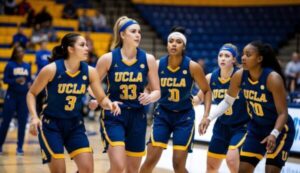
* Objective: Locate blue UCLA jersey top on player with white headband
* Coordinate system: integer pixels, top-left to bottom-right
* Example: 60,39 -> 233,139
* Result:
158,56 -> 194,111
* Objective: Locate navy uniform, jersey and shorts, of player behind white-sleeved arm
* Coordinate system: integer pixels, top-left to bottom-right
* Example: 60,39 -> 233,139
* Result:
207,68 -> 250,159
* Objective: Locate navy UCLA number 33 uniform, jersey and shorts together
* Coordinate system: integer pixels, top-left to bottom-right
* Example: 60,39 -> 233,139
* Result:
100,48 -> 149,157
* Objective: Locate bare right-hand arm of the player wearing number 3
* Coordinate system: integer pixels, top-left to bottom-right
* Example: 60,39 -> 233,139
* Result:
89,67 -> 120,115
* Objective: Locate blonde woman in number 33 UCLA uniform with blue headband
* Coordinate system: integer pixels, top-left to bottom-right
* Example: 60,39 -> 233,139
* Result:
96,16 -> 160,173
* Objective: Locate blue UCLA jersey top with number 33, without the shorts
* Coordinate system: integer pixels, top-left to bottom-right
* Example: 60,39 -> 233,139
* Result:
107,48 -> 149,108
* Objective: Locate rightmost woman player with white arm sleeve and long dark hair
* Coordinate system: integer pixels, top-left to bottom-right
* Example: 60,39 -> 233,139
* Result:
202,41 -> 295,173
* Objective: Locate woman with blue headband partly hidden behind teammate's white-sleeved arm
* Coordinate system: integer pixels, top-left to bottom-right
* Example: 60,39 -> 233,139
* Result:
199,43 -> 250,173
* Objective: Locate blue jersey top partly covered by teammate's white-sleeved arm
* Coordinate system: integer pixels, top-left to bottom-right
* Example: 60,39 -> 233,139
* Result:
209,68 -> 250,125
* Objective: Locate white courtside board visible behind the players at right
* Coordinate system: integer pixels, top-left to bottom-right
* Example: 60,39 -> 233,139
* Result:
194,105 -> 300,153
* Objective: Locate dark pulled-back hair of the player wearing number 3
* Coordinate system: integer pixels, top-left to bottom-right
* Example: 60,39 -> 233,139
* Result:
49,33 -> 81,62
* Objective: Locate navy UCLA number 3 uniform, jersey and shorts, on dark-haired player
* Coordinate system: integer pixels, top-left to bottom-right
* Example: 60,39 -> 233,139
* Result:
39,59 -> 92,163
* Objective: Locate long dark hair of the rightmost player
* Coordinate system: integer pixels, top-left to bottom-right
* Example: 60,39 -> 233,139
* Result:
250,41 -> 285,83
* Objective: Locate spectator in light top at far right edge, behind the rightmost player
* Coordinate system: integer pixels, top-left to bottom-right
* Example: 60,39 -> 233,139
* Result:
285,52 -> 300,92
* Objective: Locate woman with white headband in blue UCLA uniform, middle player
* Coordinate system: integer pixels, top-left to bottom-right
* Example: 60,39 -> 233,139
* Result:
140,27 -> 211,173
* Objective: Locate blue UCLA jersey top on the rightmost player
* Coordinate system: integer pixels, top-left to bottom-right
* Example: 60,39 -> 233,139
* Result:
241,68 -> 293,136
